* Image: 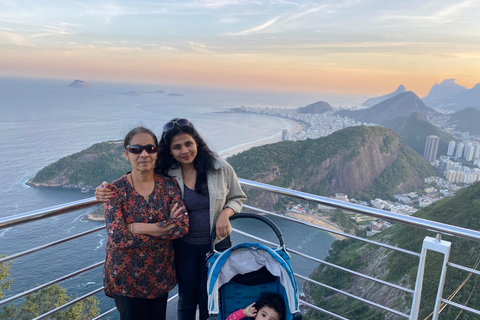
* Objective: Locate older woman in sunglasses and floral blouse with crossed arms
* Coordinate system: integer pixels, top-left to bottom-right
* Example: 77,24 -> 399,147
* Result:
103,127 -> 188,320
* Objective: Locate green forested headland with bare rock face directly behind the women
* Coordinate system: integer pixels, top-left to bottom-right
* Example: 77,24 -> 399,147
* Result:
28,126 -> 435,202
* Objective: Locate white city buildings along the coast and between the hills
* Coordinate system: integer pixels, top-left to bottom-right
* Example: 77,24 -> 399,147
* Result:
232,106 -> 480,236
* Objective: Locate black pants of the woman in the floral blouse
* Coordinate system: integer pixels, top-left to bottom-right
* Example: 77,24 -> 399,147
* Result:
113,294 -> 168,320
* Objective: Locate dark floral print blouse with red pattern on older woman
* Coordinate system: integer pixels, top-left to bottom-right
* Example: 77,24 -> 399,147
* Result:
103,174 -> 188,299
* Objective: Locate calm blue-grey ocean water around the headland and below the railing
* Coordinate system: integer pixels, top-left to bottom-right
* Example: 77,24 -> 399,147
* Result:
0,78 -> 360,319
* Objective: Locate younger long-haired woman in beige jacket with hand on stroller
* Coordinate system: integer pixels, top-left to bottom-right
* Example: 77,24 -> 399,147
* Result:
95,118 -> 246,320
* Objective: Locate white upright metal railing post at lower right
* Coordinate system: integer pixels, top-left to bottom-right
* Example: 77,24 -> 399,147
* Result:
410,234 -> 451,320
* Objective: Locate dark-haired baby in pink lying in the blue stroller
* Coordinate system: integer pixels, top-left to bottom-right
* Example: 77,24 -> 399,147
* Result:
226,292 -> 285,320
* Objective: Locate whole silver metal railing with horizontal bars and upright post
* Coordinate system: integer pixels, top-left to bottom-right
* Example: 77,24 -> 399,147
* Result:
0,179 -> 480,320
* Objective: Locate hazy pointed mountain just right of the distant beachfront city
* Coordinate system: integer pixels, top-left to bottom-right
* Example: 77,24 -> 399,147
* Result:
336,91 -> 438,124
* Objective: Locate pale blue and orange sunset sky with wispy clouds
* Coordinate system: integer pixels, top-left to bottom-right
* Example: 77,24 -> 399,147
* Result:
0,0 -> 480,97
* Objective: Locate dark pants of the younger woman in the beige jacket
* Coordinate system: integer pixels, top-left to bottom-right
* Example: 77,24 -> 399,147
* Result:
175,240 -> 210,320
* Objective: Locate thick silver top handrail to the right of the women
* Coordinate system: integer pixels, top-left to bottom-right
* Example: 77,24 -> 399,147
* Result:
238,179 -> 480,242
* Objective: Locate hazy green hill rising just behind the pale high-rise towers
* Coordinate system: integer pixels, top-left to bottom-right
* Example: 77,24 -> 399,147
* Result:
383,112 -> 457,156
